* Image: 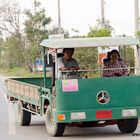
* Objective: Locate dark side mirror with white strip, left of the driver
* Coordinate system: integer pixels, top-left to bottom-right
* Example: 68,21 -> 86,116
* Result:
44,54 -> 53,67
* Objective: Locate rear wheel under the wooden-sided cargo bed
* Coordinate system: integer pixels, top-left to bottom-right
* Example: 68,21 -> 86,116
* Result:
18,101 -> 31,126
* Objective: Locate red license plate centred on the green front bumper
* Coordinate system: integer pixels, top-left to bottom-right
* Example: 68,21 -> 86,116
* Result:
96,110 -> 112,119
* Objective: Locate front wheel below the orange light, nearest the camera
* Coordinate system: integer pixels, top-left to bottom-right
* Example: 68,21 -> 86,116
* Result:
45,107 -> 65,137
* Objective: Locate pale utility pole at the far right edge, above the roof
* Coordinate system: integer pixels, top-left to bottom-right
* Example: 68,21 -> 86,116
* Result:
135,0 -> 139,33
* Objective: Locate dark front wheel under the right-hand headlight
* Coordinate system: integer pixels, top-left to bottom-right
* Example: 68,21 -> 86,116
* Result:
117,118 -> 138,133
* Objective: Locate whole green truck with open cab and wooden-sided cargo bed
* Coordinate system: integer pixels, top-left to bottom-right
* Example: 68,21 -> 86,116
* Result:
5,37 -> 140,136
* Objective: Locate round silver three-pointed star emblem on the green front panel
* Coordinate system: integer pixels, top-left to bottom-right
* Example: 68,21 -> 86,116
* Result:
96,91 -> 110,104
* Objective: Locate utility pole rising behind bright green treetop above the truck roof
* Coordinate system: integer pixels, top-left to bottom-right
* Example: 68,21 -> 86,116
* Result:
101,0 -> 105,28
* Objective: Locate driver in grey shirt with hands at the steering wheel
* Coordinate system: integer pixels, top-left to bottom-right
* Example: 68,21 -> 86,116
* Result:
58,48 -> 80,78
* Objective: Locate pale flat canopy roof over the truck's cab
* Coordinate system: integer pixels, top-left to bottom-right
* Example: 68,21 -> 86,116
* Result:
40,36 -> 140,49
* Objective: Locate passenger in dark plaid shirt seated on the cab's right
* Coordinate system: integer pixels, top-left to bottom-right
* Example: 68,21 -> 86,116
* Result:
102,50 -> 129,77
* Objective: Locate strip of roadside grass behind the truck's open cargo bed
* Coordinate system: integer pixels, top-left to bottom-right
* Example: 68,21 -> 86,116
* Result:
0,67 -> 43,77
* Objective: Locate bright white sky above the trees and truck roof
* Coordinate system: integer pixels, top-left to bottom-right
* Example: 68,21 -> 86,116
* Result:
19,0 -> 138,36
